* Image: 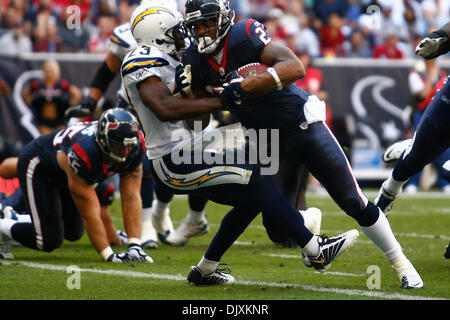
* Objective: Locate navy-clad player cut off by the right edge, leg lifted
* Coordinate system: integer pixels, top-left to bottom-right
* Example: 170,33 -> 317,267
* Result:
374,22 -> 450,258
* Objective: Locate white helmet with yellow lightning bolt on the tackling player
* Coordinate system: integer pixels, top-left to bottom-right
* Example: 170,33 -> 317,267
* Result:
130,0 -> 187,55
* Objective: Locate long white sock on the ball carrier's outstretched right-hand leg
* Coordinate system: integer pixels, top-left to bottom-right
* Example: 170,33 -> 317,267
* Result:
361,211 -> 402,261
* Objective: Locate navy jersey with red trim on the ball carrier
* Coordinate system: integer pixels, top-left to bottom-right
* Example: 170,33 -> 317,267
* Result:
183,19 -> 308,134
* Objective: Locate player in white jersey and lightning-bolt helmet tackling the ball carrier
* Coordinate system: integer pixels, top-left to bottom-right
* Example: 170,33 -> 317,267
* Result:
121,0 -> 358,285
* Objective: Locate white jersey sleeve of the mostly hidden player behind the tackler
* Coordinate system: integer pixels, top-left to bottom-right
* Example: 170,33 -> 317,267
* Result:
109,22 -> 138,102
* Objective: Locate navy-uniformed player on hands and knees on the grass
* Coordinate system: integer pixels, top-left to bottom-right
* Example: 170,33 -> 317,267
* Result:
0,109 -> 152,262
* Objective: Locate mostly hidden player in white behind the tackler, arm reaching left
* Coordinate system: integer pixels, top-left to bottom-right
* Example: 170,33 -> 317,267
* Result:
65,0 -> 209,249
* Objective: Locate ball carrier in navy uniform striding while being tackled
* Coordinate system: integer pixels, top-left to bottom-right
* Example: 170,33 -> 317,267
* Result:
176,0 -> 423,289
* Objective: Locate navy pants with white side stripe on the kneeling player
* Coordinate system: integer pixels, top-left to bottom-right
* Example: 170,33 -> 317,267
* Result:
11,143 -> 84,252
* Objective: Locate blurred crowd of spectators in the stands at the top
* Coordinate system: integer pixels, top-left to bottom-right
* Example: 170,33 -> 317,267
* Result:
0,0 -> 450,59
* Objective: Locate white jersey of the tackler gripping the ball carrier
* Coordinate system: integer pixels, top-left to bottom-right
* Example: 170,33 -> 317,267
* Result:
121,45 -> 193,160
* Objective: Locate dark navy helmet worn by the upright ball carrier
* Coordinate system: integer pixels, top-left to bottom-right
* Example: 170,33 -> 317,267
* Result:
184,0 -> 235,53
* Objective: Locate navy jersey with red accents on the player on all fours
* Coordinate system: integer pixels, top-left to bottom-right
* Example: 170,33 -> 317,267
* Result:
32,122 -> 145,186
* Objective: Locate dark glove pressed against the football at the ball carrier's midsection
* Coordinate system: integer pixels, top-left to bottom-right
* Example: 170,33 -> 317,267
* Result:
219,71 -> 249,111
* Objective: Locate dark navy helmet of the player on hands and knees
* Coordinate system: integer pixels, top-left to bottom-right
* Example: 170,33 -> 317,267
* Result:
95,108 -> 140,163
